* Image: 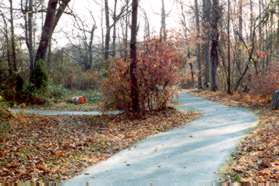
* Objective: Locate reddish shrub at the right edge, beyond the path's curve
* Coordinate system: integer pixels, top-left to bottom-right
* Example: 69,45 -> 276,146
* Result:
250,63 -> 279,97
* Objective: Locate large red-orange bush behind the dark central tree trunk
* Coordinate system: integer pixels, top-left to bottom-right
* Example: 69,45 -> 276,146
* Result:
103,39 -> 184,111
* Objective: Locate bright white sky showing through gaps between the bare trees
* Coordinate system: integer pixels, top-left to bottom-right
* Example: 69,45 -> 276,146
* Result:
0,0 -> 258,47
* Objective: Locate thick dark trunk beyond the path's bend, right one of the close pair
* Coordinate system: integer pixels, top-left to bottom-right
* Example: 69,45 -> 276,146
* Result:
210,0 -> 220,91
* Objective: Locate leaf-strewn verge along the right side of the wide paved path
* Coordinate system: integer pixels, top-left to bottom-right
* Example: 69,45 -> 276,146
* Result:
187,90 -> 279,183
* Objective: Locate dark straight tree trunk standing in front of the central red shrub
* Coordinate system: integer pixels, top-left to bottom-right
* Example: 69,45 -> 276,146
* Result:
130,0 -> 140,113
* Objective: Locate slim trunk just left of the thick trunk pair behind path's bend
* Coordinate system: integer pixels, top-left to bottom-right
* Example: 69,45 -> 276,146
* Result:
195,0 -> 202,89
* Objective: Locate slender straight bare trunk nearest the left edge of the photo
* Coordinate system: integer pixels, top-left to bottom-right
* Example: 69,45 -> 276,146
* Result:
9,0 -> 17,72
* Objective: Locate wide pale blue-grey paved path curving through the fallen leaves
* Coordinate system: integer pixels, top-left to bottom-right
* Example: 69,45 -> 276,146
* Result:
63,93 -> 257,186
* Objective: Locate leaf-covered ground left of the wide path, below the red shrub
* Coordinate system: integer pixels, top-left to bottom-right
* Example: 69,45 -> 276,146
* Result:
0,109 -> 199,183
